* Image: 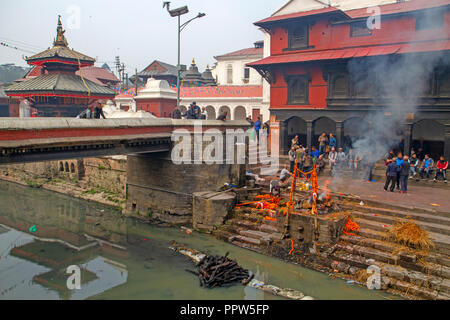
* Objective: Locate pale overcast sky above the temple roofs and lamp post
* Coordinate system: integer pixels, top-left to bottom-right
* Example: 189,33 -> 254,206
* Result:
0,0 -> 286,75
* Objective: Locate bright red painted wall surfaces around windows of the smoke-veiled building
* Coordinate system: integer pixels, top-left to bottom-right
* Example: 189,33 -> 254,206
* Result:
270,12 -> 450,109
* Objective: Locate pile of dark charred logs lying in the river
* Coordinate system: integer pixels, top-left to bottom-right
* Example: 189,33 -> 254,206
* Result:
186,252 -> 253,288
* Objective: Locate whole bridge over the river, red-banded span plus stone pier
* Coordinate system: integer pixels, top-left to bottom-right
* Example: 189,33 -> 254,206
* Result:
0,118 -> 260,225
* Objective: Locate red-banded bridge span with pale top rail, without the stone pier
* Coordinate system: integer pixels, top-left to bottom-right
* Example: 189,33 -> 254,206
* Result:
0,118 -> 248,164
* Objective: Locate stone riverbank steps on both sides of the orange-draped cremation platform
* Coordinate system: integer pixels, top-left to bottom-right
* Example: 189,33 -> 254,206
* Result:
215,181 -> 450,300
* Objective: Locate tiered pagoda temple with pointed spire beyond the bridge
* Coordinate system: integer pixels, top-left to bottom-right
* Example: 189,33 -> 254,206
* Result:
5,16 -> 114,117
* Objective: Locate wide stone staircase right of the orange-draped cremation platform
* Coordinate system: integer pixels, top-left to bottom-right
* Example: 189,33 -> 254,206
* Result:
329,201 -> 450,300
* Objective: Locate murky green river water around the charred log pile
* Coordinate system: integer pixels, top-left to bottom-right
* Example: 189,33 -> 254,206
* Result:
0,181 -> 396,300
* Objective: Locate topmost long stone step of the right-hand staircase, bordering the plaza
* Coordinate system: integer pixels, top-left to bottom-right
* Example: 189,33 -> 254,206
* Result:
339,202 -> 450,226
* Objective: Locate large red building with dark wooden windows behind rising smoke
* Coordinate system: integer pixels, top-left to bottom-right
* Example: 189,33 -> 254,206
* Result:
248,0 -> 450,158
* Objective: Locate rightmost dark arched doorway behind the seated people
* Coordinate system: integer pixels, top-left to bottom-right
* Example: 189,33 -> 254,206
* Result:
411,120 -> 445,161
